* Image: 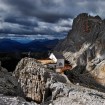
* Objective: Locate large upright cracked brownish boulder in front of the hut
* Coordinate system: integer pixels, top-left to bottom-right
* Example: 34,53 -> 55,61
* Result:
14,58 -> 67,103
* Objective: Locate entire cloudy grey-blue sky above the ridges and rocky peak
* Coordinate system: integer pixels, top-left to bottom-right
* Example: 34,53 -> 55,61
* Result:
0,0 -> 105,40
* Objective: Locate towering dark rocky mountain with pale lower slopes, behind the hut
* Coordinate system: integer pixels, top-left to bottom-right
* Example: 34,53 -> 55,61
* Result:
54,13 -> 105,86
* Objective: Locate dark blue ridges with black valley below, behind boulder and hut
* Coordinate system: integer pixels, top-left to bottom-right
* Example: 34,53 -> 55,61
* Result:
0,39 -> 59,71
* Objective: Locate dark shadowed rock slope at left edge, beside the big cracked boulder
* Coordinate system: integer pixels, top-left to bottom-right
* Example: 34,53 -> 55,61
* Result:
0,62 -> 23,96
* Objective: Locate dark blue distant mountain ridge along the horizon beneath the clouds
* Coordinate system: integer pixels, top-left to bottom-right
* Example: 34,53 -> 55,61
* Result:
0,39 -> 59,52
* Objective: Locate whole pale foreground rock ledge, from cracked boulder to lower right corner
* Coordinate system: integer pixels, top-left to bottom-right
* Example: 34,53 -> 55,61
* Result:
13,58 -> 105,105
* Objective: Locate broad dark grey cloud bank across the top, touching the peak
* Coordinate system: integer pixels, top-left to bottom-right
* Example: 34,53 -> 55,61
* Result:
4,0 -> 105,22
